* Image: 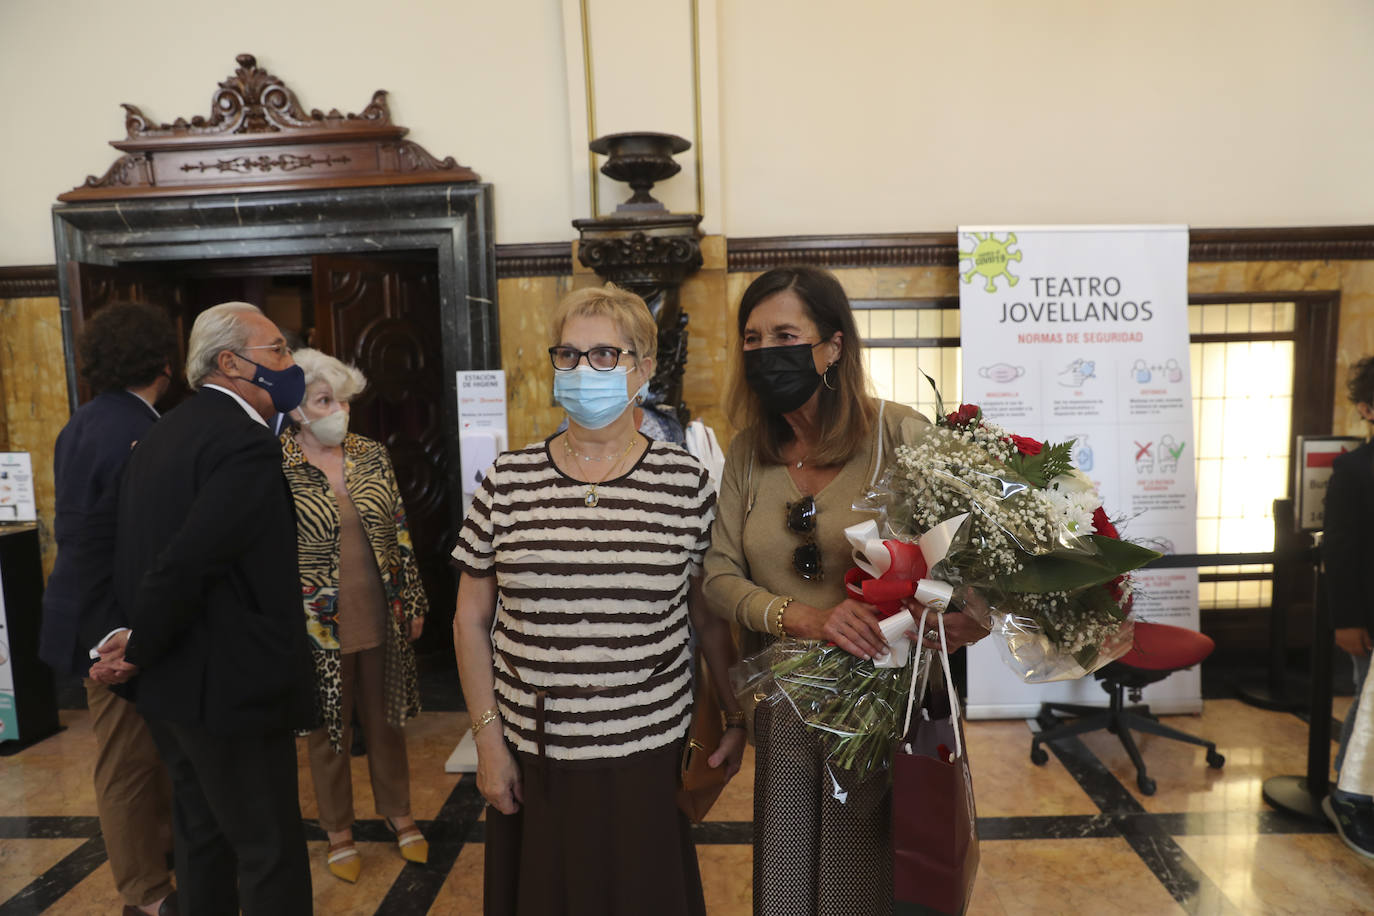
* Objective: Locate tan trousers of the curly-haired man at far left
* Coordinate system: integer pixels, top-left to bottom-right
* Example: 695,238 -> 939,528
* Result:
85,678 -> 172,906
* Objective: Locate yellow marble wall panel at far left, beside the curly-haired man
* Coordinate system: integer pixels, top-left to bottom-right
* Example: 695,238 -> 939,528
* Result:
0,297 -> 69,574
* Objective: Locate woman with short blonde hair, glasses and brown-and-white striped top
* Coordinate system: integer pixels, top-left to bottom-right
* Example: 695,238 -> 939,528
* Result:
453,287 -> 745,916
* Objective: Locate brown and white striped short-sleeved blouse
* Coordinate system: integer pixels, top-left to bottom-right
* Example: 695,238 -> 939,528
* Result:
453,441 -> 716,761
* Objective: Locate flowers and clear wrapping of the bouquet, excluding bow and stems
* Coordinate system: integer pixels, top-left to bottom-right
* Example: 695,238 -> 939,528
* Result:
867,405 -> 1158,684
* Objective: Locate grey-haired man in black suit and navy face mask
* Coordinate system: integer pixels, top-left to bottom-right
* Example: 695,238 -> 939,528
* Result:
92,302 -> 313,916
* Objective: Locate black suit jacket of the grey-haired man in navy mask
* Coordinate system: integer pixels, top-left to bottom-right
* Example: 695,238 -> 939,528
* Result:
115,389 -> 313,735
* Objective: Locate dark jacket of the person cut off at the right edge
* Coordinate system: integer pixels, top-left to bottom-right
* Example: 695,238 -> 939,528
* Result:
1322,442 -> 1374,633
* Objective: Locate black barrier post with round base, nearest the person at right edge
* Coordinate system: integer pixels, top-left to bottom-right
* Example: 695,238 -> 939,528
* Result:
1263,545 -> 1334,824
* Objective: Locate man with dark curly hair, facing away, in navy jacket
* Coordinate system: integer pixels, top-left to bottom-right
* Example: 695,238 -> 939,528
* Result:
38,302 -> 177,916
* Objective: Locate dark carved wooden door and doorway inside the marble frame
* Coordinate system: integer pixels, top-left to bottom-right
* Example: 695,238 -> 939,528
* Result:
69,253 -> 462,652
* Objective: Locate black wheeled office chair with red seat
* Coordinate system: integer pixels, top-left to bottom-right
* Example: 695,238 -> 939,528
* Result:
1031,621 -> 1226,795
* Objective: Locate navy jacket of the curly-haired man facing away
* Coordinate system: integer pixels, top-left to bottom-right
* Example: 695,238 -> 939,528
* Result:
38,391 -> 158,676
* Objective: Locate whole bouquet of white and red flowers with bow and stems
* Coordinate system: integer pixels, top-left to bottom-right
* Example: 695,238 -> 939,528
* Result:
736,404 -> 1158,795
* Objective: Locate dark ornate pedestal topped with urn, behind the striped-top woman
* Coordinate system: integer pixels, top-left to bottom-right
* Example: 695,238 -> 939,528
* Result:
573,132 -> 702,426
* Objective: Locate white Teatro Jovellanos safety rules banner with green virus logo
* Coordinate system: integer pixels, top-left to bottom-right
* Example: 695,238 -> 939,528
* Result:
959,225 -> 1202,718
